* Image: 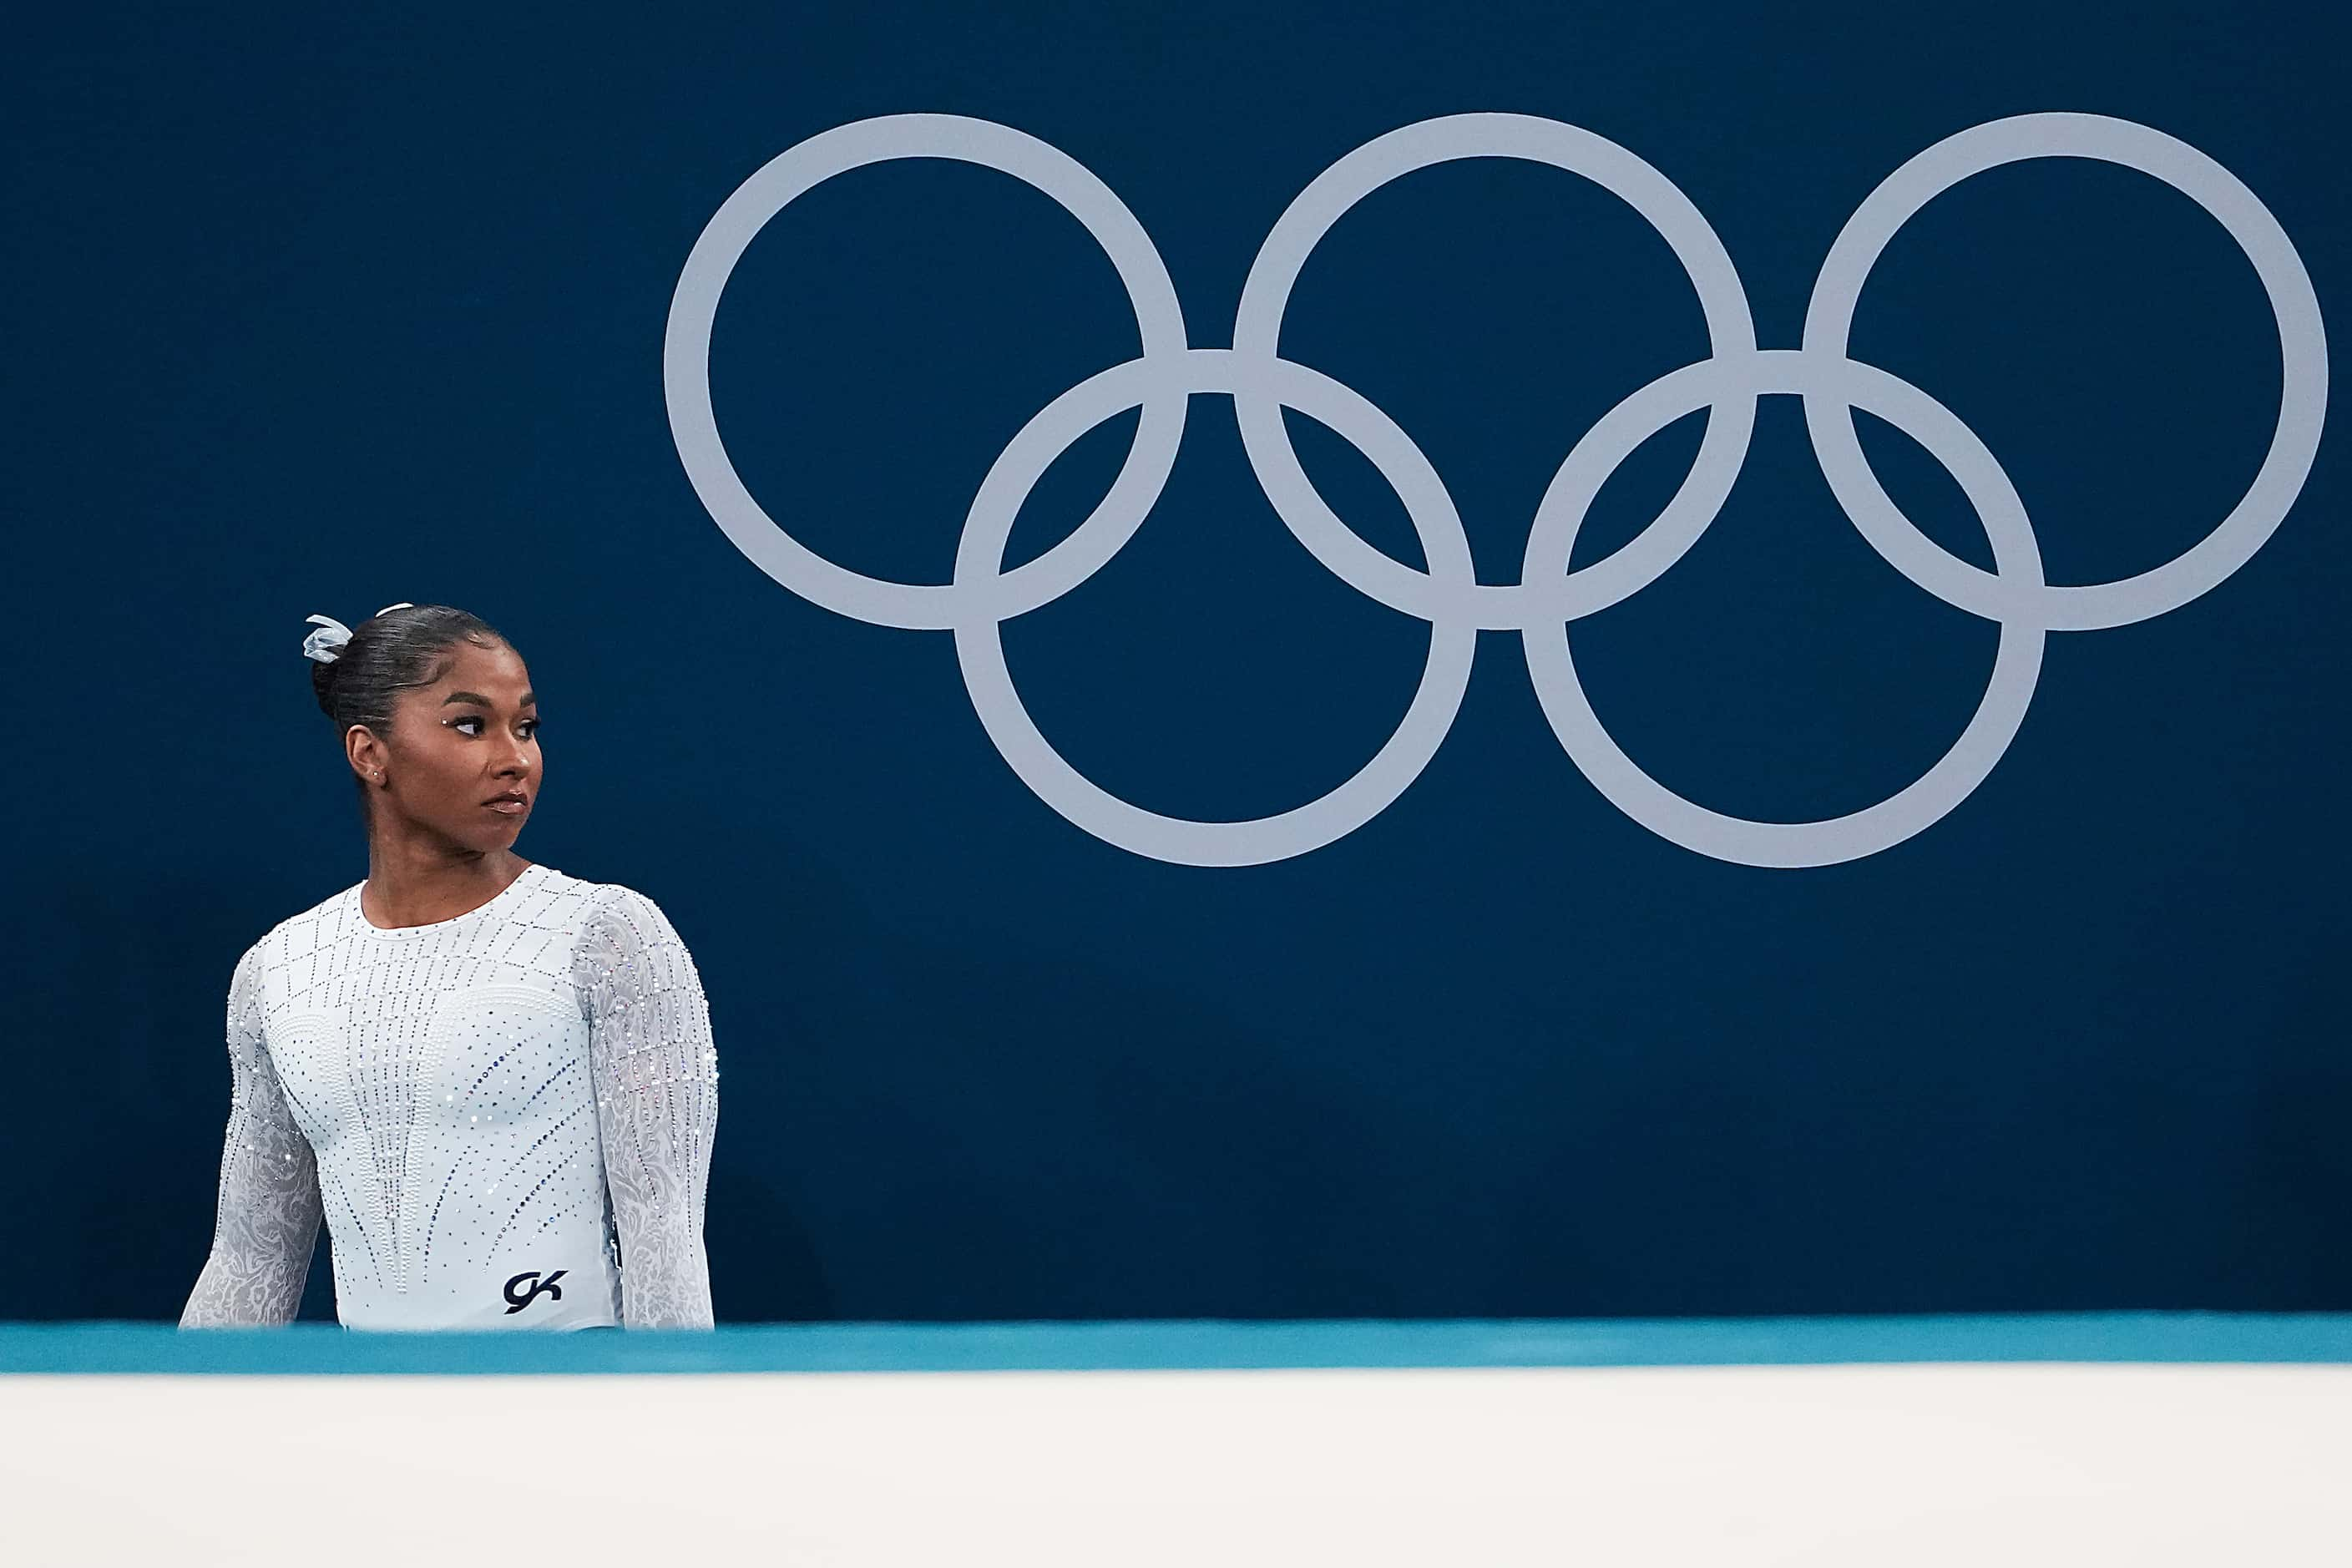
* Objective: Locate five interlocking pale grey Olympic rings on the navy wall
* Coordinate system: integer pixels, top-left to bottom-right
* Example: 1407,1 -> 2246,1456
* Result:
663,113 -> 2329,867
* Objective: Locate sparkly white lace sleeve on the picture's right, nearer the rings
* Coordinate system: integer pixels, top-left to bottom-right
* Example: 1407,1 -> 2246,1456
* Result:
572,884 -> 720,1328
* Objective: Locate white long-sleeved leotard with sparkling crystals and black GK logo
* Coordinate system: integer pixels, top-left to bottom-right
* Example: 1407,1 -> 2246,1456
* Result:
181,865 -> 717,1328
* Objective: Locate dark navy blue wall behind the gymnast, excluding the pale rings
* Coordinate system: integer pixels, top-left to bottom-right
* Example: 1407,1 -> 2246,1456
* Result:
0,0 -> 2352,1319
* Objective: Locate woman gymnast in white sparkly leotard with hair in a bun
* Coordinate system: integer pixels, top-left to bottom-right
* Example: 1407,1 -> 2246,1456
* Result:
179,604 -> 717,1328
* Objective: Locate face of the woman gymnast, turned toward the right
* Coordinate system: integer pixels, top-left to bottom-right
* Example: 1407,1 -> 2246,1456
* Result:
353,642 -> 541,853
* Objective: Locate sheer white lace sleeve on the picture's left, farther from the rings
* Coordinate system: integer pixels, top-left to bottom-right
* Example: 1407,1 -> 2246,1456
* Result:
179,945 -> 320,1328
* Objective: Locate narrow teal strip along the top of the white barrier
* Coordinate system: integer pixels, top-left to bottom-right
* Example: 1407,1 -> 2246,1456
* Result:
0,1312 -> 2352,1375
